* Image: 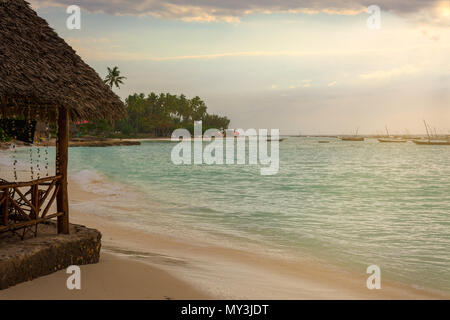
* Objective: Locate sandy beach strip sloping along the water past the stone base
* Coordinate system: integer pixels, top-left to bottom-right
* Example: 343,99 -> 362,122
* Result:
0,156 -> 449,299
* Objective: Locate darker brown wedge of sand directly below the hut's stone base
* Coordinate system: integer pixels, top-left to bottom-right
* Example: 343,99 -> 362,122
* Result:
0,253 -> 209,300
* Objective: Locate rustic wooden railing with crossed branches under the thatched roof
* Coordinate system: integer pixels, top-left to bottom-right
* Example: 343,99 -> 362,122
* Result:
0,176 -> 65,239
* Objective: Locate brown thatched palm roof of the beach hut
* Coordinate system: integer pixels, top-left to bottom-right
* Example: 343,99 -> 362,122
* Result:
0,0 -> 125,120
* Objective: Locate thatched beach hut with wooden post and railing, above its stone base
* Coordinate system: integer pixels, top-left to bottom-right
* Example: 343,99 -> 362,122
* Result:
0,0 -> 125,234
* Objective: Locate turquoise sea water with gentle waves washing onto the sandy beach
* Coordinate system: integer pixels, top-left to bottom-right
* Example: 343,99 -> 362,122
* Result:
4,138 -> 450,292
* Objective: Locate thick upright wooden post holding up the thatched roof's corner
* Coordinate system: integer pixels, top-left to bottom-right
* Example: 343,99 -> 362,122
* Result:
56,107 -> 69,234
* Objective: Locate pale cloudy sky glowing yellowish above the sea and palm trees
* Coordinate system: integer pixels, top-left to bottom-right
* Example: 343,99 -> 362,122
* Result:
30,0 -> 450,134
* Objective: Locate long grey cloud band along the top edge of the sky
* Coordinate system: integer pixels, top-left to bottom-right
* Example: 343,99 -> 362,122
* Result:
30,0 -> 447,22
